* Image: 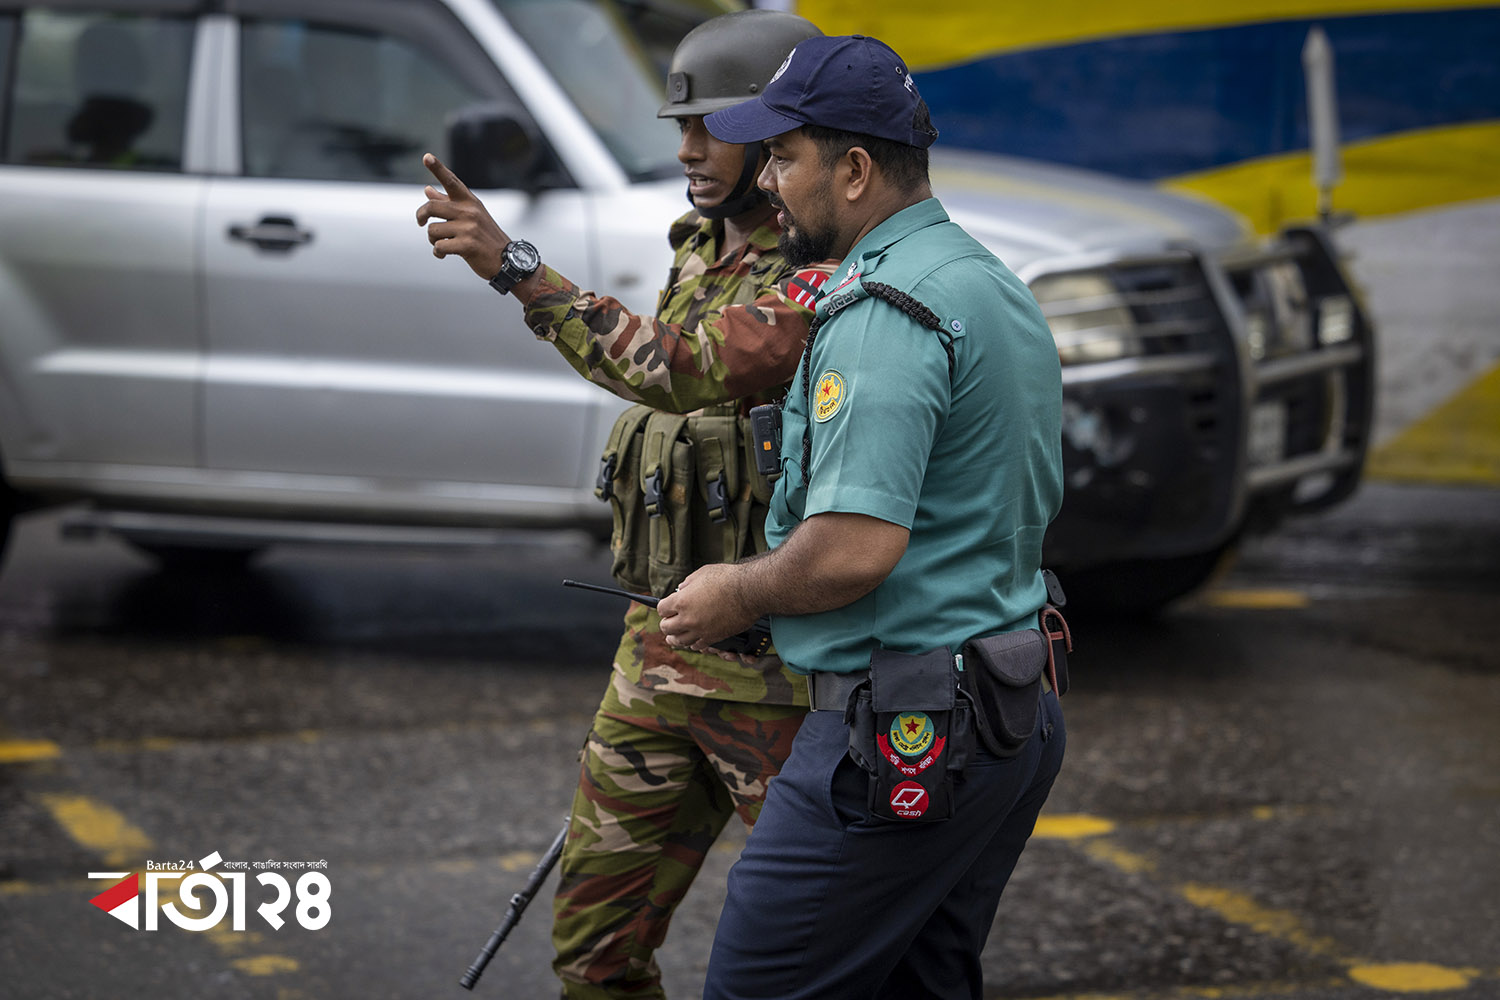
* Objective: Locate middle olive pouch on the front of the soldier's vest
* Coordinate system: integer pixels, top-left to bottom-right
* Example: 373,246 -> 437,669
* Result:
641,412 -> 695,597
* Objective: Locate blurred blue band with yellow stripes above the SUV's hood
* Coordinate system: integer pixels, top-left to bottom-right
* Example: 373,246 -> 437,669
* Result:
797,0 -> 1500,231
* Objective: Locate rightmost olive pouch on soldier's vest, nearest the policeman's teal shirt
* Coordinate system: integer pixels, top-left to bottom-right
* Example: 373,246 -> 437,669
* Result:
687,414 -> 749,567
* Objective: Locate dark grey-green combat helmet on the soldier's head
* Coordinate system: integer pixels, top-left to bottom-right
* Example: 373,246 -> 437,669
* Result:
657,10 -> 822,118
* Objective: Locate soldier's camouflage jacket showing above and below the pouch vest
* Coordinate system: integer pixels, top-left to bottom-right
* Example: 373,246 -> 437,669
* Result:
527,211 -> 836,705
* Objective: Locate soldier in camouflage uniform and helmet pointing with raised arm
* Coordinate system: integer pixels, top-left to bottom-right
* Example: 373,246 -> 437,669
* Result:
417,10 -> 831,999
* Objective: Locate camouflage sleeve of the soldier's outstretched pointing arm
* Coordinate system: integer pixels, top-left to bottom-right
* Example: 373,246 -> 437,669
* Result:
527,264 -> 833,412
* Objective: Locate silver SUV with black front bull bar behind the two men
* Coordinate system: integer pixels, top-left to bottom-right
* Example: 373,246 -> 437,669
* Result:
0,0 -> 1373,604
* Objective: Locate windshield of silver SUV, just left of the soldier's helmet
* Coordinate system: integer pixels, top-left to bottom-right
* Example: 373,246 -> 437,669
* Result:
494,0 -> 693,180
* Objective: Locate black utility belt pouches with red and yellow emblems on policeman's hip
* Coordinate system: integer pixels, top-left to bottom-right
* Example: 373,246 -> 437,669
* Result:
840,607 -> 1071,823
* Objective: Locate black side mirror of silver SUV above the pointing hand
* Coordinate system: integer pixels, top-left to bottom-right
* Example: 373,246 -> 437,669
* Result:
447,105 -> 567,193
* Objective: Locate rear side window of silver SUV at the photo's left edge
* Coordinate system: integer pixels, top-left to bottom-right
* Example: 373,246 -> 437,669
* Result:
5,10 -> 192,171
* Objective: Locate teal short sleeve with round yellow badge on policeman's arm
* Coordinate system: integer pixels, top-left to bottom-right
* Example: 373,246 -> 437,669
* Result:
803,300 -> 951,528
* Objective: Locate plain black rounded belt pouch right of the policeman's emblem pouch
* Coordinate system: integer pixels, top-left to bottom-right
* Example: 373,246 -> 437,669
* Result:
959,628 -> 1049,757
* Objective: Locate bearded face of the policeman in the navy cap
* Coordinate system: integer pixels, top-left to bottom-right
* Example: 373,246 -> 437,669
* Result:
756,129 -> 848,267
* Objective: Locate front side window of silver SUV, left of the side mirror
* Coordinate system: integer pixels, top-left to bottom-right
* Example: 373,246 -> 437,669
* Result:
240,21 -> 497,184
